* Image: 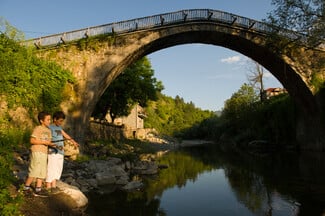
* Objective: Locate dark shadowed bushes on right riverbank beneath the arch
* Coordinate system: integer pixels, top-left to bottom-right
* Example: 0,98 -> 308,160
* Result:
189,84 -> 296,147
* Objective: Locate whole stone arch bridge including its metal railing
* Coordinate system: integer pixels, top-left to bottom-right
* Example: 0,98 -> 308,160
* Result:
24,9 -> 325,150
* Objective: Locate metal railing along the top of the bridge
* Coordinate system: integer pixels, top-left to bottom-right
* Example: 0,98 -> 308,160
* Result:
23,9 -> 298,47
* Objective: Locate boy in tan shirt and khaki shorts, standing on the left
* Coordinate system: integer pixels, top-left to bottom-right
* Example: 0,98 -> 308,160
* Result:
24,112 -> 53,197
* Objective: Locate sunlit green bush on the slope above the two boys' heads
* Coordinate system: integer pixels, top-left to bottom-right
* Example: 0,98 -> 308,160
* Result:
0,34 -> 74,114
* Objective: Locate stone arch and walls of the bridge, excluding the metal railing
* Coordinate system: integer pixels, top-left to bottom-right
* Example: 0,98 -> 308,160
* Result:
34,9 -> 324,149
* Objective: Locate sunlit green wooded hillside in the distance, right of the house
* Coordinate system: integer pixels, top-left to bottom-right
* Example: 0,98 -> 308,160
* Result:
144,94 -> 214,137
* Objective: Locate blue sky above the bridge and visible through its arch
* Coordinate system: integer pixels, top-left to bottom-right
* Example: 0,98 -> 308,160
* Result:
0,0 -> 282,111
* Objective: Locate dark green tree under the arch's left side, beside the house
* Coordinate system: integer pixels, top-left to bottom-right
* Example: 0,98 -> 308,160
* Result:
93,57 -> 164,122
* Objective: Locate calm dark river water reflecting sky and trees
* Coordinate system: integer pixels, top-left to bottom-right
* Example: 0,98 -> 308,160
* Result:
86,144 -> 325,216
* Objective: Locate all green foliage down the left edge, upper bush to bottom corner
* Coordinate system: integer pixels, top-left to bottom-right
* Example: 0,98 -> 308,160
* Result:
0,20 -> 74,215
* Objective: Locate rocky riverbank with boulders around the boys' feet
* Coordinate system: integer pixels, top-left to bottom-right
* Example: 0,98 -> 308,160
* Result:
14,143 -> 175,216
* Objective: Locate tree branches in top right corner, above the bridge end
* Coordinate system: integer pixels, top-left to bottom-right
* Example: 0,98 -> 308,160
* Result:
268,0 -> 325,46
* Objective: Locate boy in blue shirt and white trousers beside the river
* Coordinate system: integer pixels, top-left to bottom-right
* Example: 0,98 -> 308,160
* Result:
46,111 -> 79,193
